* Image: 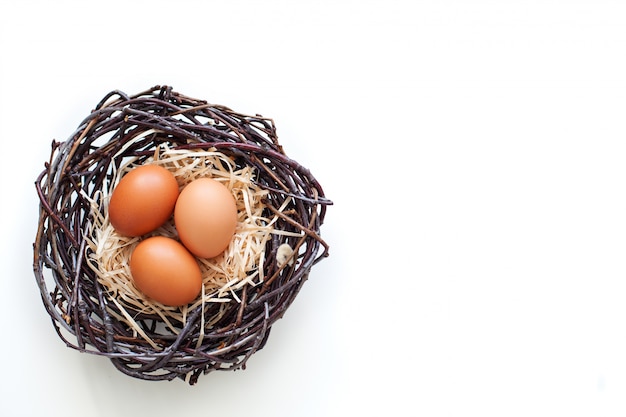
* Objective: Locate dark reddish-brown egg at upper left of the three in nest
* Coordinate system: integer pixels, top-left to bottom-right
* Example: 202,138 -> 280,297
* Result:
109,165 -> 178,236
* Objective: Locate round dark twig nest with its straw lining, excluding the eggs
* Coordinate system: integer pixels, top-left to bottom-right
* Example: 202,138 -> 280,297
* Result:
33,86 -> 332,385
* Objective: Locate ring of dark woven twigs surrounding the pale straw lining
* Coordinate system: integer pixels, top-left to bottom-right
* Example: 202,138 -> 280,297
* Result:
33,86 -> 332,384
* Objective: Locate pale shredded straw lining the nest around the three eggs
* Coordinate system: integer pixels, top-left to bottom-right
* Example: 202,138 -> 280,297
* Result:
87,148 -> 276,341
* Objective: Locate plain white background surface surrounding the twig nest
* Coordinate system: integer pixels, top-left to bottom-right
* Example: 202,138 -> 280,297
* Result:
0,0 -> 626,417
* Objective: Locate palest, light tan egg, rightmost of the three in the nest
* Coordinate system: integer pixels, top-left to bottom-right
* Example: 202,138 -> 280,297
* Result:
174,178 -> 237,258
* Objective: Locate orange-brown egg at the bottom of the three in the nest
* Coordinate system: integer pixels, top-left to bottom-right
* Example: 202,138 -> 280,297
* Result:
130,236 -> 202,306
